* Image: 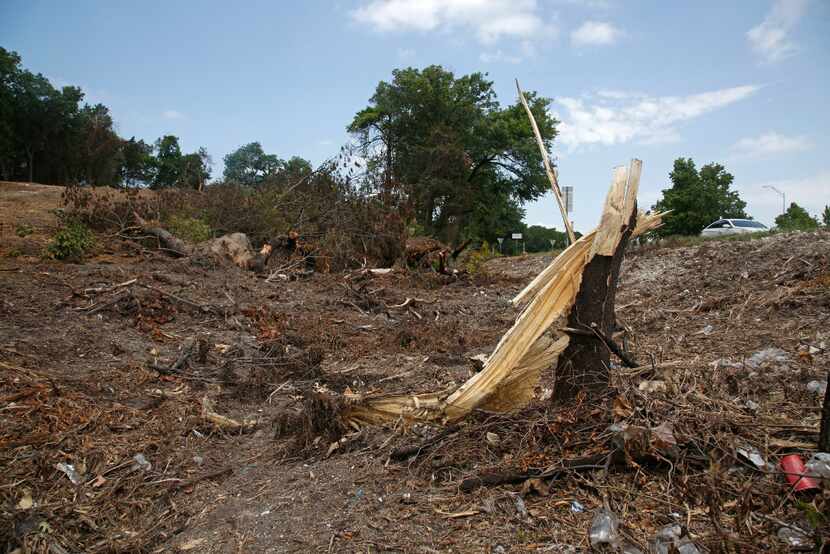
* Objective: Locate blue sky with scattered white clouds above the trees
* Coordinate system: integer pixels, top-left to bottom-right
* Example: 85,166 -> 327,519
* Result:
0,0 -> 830,231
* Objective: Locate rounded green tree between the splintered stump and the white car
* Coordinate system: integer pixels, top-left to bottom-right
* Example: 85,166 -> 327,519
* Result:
653,158 -> 747,236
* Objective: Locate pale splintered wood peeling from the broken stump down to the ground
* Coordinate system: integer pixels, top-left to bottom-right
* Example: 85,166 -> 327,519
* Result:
346,160 -> 661,426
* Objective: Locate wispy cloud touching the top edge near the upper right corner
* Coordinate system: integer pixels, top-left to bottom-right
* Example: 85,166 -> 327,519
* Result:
746,0 -> 807,62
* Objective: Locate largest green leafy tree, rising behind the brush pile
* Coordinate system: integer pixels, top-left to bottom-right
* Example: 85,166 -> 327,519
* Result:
348,65 -> 556,241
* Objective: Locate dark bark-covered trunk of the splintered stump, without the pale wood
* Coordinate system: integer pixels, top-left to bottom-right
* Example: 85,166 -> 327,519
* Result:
553,205 -> 637,403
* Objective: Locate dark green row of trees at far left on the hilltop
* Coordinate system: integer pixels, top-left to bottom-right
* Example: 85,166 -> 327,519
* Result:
0,47 -> 211,188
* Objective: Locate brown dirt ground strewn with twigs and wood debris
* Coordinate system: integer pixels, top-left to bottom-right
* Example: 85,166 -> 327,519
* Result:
0,183 -> 830,553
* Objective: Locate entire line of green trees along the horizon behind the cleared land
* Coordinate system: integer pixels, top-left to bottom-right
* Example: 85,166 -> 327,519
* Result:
0,48 -> 830,244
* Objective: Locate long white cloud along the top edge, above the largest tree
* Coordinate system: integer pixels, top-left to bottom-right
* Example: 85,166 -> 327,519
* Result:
351,0 -> 552,44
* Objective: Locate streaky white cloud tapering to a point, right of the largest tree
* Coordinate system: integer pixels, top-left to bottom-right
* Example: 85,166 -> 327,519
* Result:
554,85 -> 760,150
